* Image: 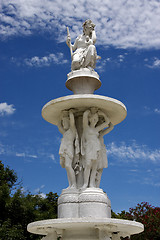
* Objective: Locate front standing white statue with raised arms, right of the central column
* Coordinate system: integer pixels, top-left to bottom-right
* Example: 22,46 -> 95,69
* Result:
81,108 -> 108,188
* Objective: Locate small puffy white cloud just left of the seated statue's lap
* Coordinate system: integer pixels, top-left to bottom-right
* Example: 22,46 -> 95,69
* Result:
24,53 -> 68,67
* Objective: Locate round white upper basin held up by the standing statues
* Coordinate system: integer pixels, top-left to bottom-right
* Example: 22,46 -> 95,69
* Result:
42,94 -> 127,125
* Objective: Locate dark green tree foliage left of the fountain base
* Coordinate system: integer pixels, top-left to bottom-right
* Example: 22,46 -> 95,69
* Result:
0,161 -> 58,240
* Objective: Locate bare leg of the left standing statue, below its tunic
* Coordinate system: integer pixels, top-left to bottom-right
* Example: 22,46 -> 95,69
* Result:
65,155 -> 76,188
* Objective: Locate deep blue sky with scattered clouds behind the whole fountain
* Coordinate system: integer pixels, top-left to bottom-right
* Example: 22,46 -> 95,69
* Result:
0,0 -> 160,212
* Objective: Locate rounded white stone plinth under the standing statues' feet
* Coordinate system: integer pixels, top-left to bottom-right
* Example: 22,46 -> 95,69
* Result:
58,188 -> 111,218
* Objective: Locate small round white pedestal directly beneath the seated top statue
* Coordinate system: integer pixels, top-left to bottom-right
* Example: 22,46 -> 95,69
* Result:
66,68 -> 101,94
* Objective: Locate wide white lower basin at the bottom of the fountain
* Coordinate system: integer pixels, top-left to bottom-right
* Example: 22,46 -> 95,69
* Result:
27,217 -> 144,239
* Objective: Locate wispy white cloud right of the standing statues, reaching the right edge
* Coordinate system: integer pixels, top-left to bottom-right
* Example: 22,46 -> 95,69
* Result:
107,142 -> 160,163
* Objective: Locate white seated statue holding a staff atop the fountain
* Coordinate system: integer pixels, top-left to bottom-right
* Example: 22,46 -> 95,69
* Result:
66,20 -> 100,70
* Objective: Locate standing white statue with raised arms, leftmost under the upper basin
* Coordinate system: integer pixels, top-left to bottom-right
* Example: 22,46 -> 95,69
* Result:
58,110 -> 79,188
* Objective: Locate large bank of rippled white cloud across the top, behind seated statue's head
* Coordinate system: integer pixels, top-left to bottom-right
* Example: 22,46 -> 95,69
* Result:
0,0 -> 160,48
